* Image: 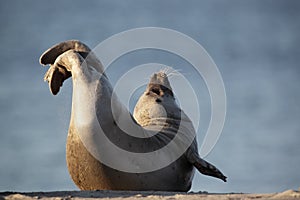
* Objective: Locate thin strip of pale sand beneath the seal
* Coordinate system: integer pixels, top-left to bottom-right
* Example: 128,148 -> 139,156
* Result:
0,190 -> 300,200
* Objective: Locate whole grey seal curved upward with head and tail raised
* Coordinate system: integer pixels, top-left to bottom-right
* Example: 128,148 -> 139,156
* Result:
40,40 -> 226,191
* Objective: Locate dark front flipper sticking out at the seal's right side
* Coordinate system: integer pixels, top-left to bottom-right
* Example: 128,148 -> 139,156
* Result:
186,149 -> 227,182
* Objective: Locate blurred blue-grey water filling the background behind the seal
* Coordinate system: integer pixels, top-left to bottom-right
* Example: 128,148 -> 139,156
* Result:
0,0 -> 300,193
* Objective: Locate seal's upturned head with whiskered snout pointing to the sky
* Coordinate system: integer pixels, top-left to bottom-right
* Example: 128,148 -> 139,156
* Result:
133,72 -> 181,126
